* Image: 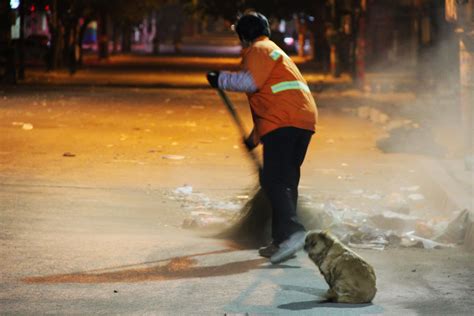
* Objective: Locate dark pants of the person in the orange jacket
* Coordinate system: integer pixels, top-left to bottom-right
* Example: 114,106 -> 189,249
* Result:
260,127 -> 313,245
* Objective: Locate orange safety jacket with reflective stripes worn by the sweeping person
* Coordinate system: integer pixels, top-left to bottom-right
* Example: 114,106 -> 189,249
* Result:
242,36 -> 318,141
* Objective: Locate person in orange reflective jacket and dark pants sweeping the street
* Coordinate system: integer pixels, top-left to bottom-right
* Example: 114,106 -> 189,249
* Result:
207,12 -> 318,264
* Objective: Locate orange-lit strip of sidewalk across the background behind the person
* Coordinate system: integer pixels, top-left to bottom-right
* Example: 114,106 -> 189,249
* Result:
18,55 -> 351,91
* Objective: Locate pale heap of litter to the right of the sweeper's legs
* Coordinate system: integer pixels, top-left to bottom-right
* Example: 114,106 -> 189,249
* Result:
299,202 -> 474,250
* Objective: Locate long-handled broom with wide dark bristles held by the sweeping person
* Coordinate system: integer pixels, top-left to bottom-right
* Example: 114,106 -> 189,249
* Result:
216,89 -> 272,248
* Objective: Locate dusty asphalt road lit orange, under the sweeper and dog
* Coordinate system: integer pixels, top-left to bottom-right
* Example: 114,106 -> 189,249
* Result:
0,79 -> 474,315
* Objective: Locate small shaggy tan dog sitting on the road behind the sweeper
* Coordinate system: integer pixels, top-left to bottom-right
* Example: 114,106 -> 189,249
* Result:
304,231 -> 377,304
